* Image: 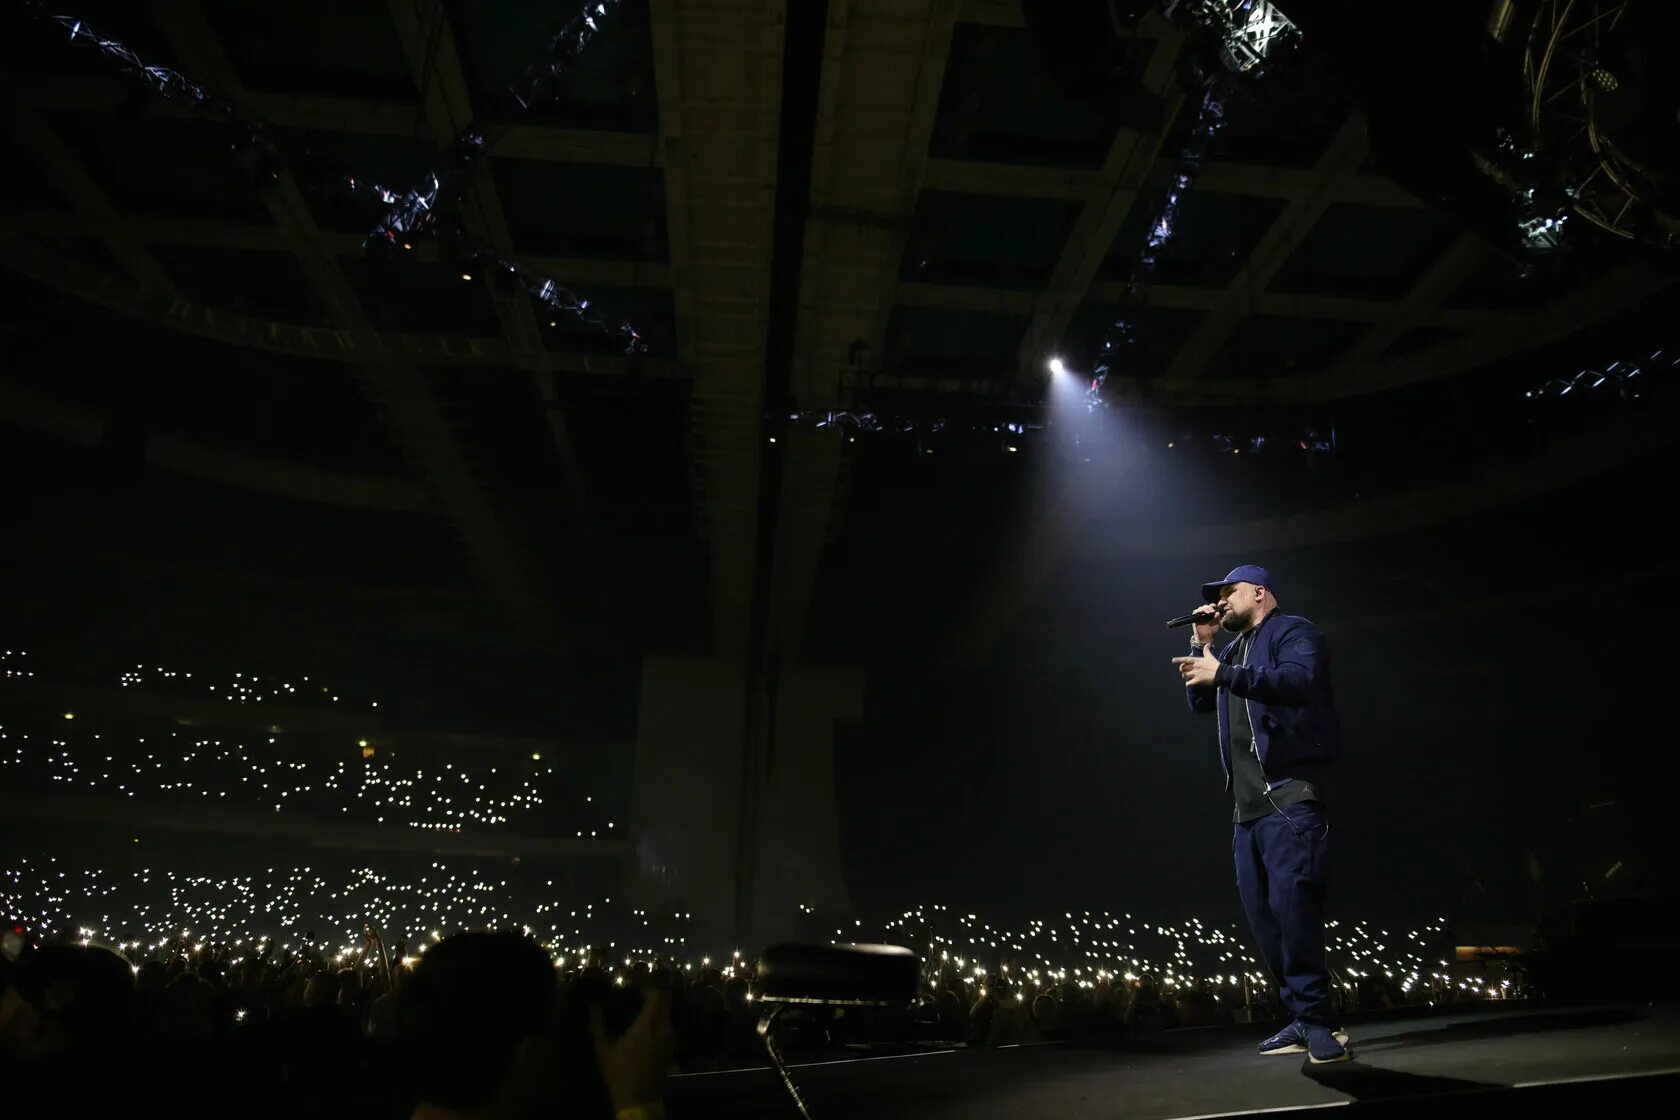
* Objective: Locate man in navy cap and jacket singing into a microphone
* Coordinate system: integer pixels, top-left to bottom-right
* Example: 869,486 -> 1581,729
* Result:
1173,564 -> 1347,1063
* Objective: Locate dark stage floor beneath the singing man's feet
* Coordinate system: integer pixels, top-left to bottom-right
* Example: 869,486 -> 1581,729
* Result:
669,1004 -> 1680,1120
